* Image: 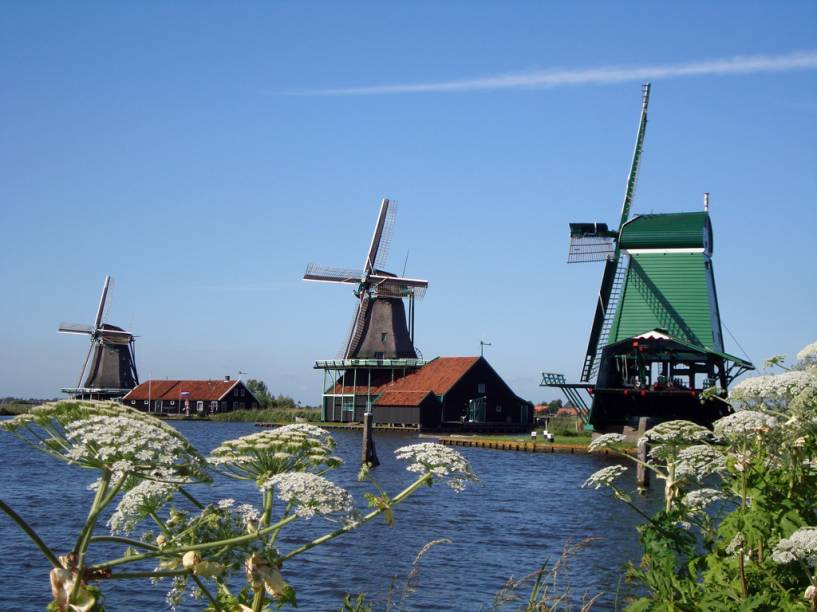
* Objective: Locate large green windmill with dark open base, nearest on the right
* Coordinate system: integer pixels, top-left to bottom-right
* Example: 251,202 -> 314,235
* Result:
542,84 -> 754,431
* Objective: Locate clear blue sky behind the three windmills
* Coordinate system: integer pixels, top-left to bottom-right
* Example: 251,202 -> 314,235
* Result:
0,1 -> 817,403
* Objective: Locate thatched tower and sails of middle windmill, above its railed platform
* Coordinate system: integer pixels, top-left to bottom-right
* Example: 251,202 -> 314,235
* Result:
304,198 -> 428,359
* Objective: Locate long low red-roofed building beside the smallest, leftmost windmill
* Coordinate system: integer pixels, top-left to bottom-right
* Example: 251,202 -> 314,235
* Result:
122,376 -> 260,414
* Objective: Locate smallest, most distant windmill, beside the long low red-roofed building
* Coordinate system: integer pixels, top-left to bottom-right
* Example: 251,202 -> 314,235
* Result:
58,276 -> 139,397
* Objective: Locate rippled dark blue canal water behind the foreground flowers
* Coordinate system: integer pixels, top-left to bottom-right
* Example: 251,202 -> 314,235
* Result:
0,422 -> 660,611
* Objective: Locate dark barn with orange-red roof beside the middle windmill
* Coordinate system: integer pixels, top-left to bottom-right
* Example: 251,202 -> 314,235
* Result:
372,357 -> 533,428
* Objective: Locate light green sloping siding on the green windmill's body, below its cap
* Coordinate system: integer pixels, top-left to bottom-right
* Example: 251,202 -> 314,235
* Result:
608,253 -> 717,350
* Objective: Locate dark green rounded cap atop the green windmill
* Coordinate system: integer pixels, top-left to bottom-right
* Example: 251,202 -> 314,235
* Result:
620,212 -> 710,249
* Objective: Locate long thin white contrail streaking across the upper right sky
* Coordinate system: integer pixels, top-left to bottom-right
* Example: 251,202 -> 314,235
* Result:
290,51 -> 817,96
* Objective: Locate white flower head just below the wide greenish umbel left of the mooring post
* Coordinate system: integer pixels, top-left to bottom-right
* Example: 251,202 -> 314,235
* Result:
261,472 -> 357,523
